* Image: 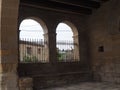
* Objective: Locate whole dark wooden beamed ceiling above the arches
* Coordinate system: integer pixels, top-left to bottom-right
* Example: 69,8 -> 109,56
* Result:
20,0 -> 108,15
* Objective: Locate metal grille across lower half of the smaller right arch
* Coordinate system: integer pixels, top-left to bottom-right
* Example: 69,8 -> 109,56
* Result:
57,40 -> 79,62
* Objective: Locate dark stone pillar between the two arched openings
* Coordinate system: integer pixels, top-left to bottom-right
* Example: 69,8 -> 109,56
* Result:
44,32 -> 57,63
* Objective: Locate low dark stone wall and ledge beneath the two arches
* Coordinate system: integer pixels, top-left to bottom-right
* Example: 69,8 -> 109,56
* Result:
18,62 -> 92,90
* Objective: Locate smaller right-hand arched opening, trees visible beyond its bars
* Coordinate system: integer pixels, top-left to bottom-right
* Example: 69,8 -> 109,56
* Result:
56,21 -> 80,62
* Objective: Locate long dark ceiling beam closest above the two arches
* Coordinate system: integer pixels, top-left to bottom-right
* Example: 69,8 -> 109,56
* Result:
20,0 -> 92,15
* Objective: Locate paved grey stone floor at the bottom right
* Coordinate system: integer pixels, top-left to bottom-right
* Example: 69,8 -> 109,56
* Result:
42,82 -> 120,90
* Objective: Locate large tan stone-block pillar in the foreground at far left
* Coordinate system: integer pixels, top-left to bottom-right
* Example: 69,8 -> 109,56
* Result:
0,0 -> 19,90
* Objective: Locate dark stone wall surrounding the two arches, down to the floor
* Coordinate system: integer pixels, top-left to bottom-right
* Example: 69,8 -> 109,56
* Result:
18,5 -> 92,90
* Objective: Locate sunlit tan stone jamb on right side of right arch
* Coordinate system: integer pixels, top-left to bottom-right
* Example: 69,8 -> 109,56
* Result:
73,35 -> 80,61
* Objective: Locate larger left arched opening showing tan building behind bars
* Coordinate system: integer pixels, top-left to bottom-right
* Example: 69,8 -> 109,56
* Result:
19,18 -> 48,63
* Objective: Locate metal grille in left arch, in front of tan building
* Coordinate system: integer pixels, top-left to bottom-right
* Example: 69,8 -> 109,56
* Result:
19,39 -> 48,63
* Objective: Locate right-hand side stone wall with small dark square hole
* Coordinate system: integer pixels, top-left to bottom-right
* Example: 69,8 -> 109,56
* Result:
88,0 -> 120,83
